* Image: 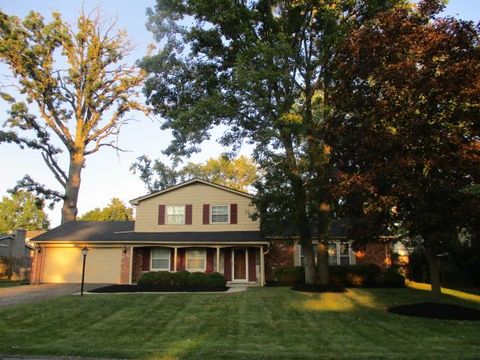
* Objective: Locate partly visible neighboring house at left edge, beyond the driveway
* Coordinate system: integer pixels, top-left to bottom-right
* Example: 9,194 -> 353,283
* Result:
0,230 -> 33,280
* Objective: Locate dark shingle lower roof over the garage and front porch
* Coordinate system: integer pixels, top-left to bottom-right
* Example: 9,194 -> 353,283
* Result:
32,221 -> 265,243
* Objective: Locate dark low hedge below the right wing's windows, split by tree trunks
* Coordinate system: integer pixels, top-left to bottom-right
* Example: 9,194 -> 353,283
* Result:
275,264 -> 405,287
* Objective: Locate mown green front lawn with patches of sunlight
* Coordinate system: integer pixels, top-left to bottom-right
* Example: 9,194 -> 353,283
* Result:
0,288 -> 480,359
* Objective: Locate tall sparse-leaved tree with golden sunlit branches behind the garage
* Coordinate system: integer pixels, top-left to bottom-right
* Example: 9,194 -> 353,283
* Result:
0,11 -> 145,223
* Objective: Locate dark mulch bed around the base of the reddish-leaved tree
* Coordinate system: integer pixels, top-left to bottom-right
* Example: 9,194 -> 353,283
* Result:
387,302 -> 480,321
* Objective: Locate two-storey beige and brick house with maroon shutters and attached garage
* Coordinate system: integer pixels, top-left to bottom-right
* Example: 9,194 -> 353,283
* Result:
32,179 -> 389,285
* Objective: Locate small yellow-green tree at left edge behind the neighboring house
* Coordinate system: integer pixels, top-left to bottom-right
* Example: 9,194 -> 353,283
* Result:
0,191 -> 50,233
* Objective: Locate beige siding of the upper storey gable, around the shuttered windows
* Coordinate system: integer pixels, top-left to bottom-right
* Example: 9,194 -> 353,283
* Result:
135,183 -> 260,232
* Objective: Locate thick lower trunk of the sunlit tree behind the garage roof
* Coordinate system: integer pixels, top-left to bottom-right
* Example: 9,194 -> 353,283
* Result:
62,151 -> 85,224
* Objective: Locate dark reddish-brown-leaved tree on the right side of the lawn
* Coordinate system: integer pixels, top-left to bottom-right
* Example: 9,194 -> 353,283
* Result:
327,0 -> 480,297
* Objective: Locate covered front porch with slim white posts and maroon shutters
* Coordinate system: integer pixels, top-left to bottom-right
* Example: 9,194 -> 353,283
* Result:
131,244 -> 265,286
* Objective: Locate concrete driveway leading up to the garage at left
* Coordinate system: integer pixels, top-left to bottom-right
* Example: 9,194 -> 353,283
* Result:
0,284 -> 103,307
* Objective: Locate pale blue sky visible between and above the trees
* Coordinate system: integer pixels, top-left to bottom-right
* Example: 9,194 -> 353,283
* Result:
0,0 -> 480,227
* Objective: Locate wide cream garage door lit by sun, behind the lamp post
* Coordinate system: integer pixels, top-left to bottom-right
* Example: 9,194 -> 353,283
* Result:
42,248 -> 122,284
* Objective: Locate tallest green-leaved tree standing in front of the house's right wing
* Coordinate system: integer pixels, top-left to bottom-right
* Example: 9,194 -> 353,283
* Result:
143,0 -> 399,283
